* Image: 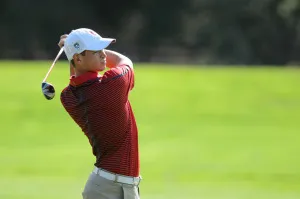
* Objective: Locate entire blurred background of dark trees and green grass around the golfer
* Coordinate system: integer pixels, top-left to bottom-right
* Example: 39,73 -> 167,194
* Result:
0,0 -> 300,199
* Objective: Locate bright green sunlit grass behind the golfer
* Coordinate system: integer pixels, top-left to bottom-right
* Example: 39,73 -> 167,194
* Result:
0,61 -> 300,199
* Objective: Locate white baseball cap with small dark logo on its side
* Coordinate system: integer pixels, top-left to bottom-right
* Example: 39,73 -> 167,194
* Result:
64,28 -> 116,61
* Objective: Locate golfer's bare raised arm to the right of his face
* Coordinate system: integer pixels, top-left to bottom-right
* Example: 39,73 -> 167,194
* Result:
105,50 -> 133,68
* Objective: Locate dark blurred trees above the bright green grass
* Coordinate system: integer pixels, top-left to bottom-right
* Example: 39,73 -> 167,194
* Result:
0,0 -> 300,65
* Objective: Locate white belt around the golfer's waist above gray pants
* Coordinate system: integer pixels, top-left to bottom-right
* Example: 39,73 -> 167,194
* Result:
93,167 -> 142,186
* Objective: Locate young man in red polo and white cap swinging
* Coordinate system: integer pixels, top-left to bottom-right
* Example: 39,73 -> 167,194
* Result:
58,28 -> 141,199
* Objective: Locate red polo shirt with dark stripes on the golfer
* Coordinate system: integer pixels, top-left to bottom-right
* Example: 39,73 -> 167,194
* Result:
61,65 -> 139,177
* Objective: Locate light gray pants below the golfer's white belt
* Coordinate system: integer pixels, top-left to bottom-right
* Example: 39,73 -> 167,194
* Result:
82,173 -> 140,199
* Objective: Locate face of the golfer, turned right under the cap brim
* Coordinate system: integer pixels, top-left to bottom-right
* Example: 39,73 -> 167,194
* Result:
74,50 -> 106,73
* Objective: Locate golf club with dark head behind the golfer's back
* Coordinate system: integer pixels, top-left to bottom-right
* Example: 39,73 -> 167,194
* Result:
42,48 -> 64,100
